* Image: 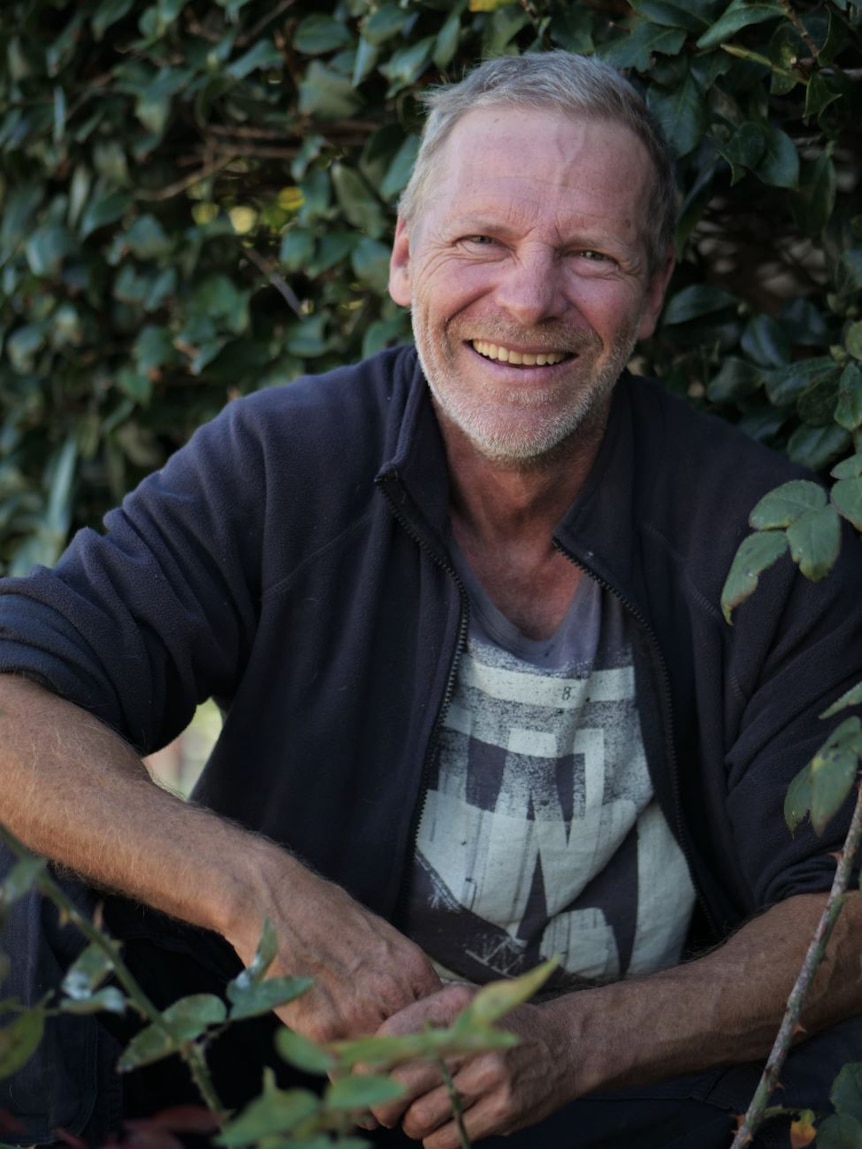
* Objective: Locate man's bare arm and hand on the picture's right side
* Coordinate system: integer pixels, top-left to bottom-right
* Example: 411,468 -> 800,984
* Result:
375,894 -> 862,1149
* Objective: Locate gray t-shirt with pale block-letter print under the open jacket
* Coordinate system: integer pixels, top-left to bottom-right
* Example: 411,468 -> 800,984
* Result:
407,556 -> 694,992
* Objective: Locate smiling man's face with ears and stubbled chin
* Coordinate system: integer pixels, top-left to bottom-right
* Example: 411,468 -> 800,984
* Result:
390,108 -> 670,463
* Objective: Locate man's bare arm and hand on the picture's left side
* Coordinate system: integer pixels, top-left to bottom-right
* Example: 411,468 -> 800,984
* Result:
0,674 -> 439,1039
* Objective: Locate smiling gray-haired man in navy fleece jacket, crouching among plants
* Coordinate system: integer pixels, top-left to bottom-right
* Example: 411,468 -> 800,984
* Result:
0,53 -> 862,1149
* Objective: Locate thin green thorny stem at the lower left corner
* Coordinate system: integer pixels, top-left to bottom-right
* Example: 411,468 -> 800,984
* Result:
0,824 -> 228,1123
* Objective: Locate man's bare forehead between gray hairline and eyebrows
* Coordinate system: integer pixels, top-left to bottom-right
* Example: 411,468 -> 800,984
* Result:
423,106 -> 653,244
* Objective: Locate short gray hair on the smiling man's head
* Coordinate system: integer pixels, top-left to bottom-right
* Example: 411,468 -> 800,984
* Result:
398,49 -> 678,275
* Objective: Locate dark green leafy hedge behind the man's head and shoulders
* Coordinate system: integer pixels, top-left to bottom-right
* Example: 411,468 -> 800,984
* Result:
0,0 -> 862,573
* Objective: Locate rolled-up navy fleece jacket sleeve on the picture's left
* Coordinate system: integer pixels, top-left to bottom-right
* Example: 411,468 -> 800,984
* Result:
0,400 -> 267,754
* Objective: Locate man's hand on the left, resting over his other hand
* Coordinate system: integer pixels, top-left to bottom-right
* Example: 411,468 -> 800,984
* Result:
229,851 -> 440,1042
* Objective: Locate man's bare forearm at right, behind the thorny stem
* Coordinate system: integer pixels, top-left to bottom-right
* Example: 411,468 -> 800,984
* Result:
553,894 -> 862,1092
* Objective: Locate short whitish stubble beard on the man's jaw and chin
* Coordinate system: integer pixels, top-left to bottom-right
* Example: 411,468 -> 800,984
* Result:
411,307 -> 636,470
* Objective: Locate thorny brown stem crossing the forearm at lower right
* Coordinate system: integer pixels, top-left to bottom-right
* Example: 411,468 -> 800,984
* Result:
731,787 -> 862,1149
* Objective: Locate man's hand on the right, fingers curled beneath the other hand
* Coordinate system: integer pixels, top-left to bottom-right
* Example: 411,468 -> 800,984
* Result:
363,985 -> 576,1149
